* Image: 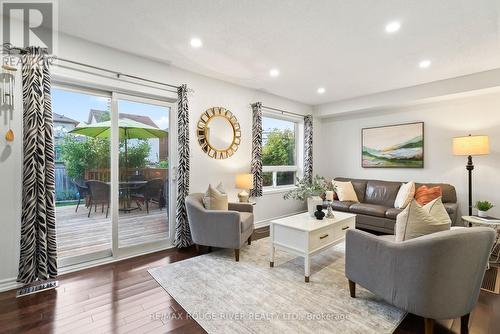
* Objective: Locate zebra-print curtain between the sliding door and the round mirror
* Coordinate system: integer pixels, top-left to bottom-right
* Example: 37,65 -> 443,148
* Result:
174,85 -> 193,248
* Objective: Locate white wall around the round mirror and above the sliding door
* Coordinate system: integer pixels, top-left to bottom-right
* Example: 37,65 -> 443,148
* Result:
0,36 -> 312,285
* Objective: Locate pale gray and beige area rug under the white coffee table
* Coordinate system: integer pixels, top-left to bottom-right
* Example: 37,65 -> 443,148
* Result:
149,238 -> 406,334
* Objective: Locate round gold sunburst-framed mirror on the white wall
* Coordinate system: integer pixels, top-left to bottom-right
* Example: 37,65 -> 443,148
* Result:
196,107 -> 241,159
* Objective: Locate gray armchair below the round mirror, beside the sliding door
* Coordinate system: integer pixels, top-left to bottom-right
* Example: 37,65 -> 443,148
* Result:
186,193 -> 254,261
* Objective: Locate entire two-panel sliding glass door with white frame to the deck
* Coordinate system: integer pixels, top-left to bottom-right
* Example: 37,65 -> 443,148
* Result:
52,86 -> 175,267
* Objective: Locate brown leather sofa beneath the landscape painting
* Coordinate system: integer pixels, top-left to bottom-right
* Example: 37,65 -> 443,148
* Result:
332,177 -> 458,234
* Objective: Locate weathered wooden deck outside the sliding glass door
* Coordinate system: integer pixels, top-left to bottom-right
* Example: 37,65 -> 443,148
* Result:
56,205 -> 169,259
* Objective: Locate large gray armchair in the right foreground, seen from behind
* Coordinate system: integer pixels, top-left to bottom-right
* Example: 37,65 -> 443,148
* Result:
345,227 -> 495,333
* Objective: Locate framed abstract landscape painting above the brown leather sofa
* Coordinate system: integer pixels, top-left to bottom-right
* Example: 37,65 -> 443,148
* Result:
361,122 -> 424,168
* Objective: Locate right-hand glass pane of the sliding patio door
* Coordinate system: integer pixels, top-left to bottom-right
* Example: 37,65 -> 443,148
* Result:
116,95 -> 170,248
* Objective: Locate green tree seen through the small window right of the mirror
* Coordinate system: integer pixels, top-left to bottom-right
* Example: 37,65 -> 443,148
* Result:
262,129 -> 295,166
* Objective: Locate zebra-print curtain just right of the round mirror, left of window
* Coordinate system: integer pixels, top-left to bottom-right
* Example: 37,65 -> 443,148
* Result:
250,102 -> 262,197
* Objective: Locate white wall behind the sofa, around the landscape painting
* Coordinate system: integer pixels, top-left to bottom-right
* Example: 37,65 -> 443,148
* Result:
315,92 -> 500,216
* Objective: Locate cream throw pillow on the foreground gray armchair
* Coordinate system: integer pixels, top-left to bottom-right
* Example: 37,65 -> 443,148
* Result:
395,197 -> 451,241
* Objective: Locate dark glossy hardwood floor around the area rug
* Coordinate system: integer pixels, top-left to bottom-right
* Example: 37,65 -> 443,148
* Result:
0,229 -> 500,334
